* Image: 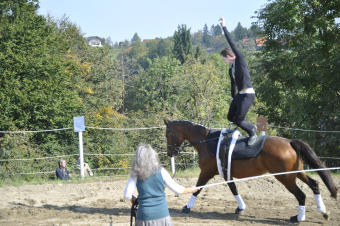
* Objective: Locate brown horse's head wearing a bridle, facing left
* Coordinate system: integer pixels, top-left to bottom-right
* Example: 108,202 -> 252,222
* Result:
164,119 -> 184,157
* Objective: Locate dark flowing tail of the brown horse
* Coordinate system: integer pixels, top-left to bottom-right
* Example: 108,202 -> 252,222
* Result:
290,140 -> 338,199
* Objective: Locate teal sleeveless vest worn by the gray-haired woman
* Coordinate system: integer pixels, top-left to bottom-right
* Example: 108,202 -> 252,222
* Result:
136,172 -> 170,221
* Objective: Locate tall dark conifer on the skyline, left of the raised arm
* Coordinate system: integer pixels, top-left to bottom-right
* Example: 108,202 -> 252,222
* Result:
172,24 -> 192,64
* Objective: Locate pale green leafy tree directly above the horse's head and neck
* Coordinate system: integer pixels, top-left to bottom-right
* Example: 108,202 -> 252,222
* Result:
172,54 -> 231,126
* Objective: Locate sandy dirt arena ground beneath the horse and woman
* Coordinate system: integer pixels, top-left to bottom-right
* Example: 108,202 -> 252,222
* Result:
0,175 -> 340,226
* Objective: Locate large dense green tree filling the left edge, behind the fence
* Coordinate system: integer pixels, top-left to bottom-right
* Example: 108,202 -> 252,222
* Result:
0,0 -> 84,177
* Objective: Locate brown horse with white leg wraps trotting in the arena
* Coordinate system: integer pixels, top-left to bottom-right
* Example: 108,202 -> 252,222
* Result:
164,120 -> 337,222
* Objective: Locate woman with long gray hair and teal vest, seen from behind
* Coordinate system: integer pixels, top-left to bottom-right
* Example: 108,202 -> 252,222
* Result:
124,144 -> 198,226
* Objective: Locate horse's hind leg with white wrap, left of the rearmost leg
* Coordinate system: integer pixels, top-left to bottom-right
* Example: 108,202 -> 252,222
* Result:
275,174 -> 306,222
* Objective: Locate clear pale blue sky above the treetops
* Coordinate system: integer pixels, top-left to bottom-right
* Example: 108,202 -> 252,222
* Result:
38,0 -> 268,42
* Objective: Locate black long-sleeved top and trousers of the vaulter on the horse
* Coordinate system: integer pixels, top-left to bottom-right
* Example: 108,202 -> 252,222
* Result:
223,27 -> 255,136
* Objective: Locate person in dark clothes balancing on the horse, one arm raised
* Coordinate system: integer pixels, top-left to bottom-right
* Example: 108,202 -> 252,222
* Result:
219,17 -> 257,145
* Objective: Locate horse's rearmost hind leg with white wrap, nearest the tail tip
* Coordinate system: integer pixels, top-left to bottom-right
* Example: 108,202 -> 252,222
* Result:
297,173 -> 328,219
